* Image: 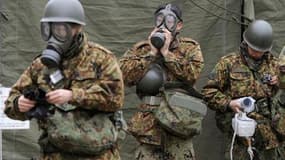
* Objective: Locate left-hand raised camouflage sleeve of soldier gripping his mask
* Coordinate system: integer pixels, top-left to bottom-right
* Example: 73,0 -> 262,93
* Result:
120,42 -> 156,86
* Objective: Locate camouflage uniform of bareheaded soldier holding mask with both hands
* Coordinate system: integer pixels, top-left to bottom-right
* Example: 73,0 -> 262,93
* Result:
120,38 -> 204,160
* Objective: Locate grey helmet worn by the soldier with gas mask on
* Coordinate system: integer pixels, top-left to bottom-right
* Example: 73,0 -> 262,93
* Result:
41,0 -> 85,25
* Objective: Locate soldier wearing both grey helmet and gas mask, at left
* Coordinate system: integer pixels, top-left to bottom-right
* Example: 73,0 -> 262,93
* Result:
5,0 -> 124,160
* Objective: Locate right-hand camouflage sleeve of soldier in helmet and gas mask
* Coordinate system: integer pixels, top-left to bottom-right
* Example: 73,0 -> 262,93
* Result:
70,54 -> 124,112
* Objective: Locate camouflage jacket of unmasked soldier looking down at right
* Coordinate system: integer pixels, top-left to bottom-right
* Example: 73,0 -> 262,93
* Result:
202,53 -> 278,148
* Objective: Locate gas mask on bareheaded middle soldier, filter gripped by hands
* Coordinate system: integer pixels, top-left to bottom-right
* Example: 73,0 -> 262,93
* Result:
150,4 -> 181,49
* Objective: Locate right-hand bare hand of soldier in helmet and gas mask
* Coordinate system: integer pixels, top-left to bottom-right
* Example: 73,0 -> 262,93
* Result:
46,89 -> 72,105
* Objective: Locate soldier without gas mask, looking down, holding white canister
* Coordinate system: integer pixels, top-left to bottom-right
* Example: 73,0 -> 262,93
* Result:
202,20 -> 284,160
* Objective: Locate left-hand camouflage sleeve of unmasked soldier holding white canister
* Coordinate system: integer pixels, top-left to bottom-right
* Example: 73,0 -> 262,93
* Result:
202,61 -> 231,112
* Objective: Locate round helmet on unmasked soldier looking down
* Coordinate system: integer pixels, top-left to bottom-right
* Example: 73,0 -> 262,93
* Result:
243,20 -> 273,52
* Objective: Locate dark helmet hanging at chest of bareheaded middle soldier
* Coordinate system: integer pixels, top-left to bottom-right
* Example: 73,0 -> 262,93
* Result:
136,64 -> 164,96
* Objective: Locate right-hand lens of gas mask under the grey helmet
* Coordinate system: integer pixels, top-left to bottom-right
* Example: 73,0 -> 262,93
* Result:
51,23 -> 72,42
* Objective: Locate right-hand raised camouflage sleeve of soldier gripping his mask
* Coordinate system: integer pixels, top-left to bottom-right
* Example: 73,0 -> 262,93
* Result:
164,43 -> 204,85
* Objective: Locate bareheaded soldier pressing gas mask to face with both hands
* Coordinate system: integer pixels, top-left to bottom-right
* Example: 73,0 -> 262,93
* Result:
120,4 -> 204,160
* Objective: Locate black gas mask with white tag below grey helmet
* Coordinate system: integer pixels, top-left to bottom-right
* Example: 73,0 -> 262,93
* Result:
41,22 -> 76,86
